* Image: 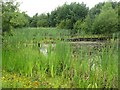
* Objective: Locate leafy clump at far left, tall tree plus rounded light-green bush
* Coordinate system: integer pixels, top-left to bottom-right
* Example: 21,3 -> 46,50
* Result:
2,0 -> 28,32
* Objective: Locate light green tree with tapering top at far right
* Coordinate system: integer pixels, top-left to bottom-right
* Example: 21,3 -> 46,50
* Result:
93,2 -> 118,34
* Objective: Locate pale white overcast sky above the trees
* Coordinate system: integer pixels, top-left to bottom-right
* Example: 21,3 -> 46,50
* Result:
17,0 -> 118,16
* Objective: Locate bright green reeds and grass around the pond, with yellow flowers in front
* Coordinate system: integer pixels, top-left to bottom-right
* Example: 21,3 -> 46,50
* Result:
1,28 -> 118,88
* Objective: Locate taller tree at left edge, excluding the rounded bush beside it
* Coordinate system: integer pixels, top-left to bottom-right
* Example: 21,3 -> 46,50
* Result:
2,1 -> 18,32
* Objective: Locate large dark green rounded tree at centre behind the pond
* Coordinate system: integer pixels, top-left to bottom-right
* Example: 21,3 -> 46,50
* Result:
50,3 -> 88,29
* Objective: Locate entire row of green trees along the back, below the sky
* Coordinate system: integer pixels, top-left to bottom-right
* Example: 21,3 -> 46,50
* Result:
2,0 -> 120,34
